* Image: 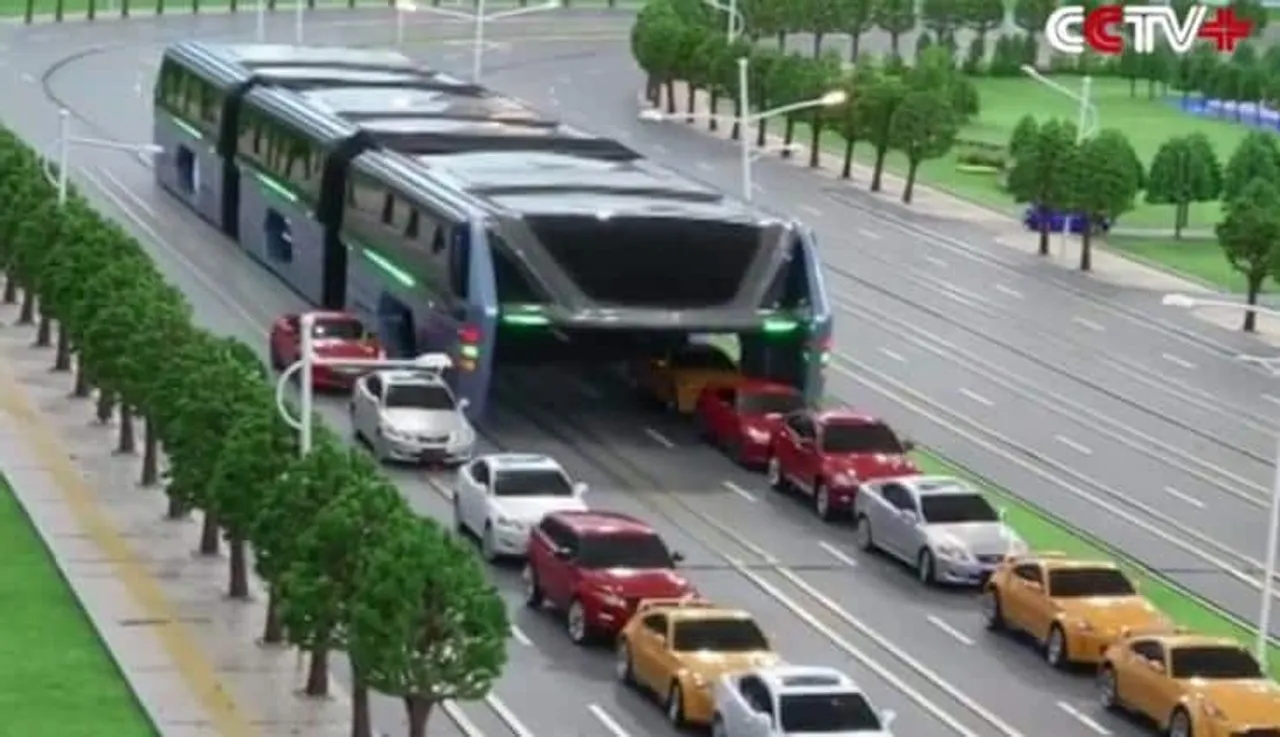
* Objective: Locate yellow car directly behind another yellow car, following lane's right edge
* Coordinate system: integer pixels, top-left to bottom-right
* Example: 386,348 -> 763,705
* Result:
983,553 -> 1174,668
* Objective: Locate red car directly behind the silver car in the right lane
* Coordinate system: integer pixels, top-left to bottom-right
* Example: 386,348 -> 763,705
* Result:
768,411 -> 920,521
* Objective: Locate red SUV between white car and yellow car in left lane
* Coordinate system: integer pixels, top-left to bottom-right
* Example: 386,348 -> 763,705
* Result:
525,511 -> 698,645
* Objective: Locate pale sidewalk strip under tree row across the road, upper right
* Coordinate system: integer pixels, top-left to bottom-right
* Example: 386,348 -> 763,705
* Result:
655,82 -> 1280,347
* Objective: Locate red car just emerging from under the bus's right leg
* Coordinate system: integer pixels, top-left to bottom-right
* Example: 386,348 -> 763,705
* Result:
694,379 -> 804,466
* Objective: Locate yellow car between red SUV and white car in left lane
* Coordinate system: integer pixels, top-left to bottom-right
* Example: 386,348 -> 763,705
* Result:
616,599 -> 782,727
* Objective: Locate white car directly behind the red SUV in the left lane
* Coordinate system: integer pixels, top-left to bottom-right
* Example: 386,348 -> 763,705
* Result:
453,453 -> 586,562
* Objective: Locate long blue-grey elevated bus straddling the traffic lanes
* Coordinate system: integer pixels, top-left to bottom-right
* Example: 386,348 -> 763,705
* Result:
157,47 -> 831,413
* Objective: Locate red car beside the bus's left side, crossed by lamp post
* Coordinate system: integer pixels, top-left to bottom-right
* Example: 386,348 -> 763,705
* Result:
269,312 -> 384,389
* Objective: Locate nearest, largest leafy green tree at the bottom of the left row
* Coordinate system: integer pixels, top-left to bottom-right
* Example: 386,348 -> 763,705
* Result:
349,519 -> 511,737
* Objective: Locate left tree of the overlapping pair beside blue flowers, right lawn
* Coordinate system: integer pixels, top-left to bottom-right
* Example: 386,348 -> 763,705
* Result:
1009,120 -> 1076,256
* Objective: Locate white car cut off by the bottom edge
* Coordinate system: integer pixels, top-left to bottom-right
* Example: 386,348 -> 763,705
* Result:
712,665 -> 895,737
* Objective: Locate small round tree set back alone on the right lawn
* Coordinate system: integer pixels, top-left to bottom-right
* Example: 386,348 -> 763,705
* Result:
1147,133 -> 1222,239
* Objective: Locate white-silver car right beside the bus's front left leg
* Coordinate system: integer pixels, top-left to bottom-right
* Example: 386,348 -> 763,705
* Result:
351,371 -> 476,464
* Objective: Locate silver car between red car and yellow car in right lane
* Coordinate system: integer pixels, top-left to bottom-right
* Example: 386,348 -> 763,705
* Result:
854,476 -> 1027,583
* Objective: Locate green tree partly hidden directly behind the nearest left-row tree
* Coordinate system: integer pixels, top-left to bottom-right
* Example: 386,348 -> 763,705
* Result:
278,450 -> 412,696
